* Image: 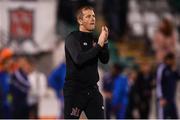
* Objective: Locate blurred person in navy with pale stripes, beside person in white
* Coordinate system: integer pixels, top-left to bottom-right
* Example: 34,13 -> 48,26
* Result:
10,56 -> 30,119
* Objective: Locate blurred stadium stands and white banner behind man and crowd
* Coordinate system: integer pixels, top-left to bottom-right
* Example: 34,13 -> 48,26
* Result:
0,0 -> 180,118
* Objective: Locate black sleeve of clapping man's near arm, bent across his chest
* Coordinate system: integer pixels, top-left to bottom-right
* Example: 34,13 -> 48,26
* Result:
65,34 -> 102,66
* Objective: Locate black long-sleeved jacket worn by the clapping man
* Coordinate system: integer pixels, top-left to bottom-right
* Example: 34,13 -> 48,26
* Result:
64,31 -> 109,94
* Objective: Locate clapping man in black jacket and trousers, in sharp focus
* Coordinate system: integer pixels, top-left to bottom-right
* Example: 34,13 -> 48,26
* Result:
64,6 -> 109,119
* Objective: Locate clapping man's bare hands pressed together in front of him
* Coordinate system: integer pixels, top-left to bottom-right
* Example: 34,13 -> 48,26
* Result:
98,26 -> 109,47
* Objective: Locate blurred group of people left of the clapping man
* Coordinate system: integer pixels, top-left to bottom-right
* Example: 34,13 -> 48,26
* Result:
0,48 -> 66,119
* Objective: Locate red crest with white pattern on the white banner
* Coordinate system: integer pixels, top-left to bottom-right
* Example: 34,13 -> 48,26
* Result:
9,8 -> 33,41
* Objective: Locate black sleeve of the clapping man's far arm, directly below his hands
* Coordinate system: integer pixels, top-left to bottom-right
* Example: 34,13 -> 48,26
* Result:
99,44 -> 109,64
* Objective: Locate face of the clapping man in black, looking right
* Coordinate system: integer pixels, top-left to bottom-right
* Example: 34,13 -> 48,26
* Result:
79,10 -> 96,32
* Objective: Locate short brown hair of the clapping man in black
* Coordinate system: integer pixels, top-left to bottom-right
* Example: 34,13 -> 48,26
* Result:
76,6 -> 94,20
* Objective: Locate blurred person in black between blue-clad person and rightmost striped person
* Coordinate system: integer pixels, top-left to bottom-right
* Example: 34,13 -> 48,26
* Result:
136,60 -> 155,119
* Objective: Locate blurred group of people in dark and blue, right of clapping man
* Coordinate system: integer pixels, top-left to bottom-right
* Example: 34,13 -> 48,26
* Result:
103,53 -> 180,119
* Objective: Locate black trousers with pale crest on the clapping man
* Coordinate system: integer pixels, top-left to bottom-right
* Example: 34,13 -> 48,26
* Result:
64,87 -> 104,119
